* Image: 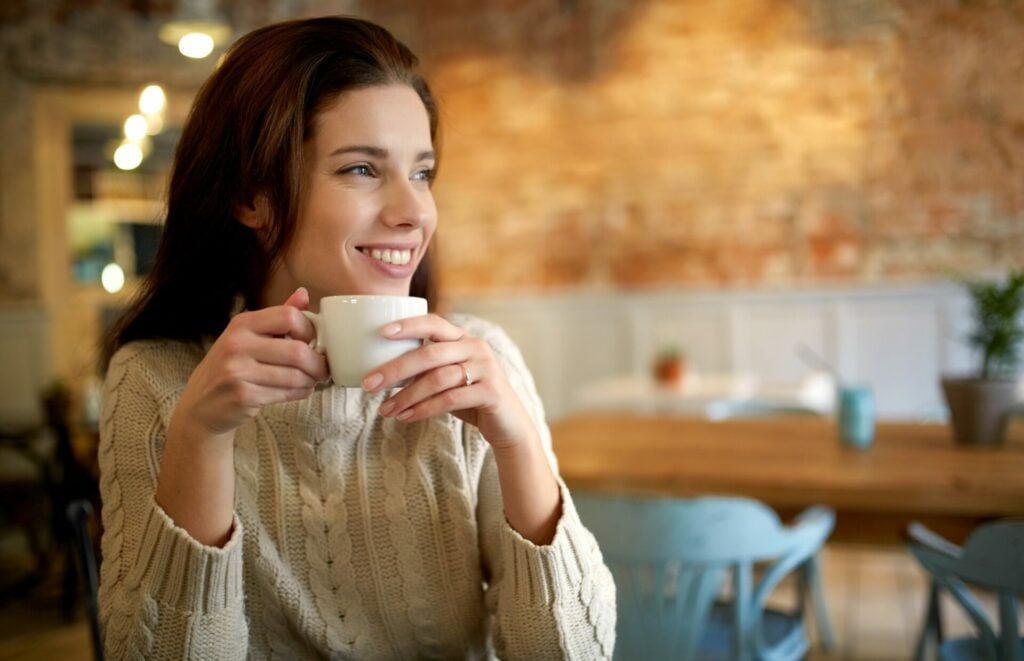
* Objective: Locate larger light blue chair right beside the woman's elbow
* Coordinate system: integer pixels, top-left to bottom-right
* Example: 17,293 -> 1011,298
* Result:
573,493 -> 836,661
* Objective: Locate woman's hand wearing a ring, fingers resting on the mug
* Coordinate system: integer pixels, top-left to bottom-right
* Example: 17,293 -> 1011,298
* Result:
362,314 -> 537,450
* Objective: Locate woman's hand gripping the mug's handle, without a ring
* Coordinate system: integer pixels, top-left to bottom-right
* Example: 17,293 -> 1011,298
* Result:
174,288 -> 329,437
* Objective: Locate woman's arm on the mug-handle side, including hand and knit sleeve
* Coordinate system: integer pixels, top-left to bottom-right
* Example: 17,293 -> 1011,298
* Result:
99,292 -> 327,659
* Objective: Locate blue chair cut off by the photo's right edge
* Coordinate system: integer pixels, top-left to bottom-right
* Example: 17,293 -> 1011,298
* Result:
906,520 -> 1024,661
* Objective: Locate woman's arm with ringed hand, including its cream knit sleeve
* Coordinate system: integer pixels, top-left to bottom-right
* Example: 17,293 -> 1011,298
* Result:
367,317 -> 615,659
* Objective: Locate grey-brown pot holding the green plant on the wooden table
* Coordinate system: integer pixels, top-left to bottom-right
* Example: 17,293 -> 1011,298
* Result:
942,378 -> 1017,447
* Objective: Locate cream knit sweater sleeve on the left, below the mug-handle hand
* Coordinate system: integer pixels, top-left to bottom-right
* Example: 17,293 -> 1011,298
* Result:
99,342 -> 248,659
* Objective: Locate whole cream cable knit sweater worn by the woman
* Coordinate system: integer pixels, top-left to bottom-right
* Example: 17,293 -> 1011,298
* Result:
99,316 -> 615,661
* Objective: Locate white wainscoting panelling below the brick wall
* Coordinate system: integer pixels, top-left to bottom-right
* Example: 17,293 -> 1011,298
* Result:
452,281 -> 974,420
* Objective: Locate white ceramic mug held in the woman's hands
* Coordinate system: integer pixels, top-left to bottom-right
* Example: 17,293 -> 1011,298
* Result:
303,296 -> 427,388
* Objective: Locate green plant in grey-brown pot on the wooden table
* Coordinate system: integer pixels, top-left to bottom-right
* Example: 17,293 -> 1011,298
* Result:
942,271 -> 1024,445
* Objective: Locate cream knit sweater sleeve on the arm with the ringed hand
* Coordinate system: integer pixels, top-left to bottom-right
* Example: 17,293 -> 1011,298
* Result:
456,320 -> 615,660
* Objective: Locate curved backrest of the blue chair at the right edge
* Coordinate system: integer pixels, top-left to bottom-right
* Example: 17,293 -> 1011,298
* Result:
907,519 -> 1024,661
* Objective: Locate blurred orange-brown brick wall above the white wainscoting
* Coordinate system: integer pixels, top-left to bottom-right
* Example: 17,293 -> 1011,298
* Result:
361,0 -> 1024,295
